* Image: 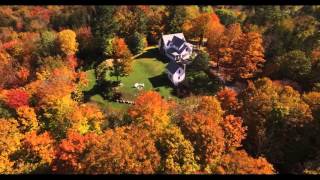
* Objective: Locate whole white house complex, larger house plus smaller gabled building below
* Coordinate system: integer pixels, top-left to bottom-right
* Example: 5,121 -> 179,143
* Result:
159,33 -> 193,86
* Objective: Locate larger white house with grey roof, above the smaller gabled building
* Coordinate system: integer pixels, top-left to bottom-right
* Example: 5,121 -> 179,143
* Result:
159,33 -> 193,63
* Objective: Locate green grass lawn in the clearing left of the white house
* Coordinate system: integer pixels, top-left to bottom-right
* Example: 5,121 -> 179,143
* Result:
84,47 -> 176,109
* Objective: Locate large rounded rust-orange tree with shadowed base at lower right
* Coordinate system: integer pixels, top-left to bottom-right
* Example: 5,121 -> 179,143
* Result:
243,78 -> 317,173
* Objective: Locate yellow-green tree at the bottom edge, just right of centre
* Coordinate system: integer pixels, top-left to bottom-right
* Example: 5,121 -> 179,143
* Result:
158,126 -> 200,174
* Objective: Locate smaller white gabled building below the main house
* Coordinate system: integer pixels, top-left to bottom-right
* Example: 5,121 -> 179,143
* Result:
166,62 -> 186,86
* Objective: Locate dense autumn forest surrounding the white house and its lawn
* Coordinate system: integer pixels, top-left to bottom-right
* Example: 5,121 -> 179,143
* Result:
0,5 -> 320,174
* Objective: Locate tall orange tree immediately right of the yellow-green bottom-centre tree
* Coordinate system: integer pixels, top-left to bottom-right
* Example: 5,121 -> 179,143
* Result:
175,96 -> 225,168
